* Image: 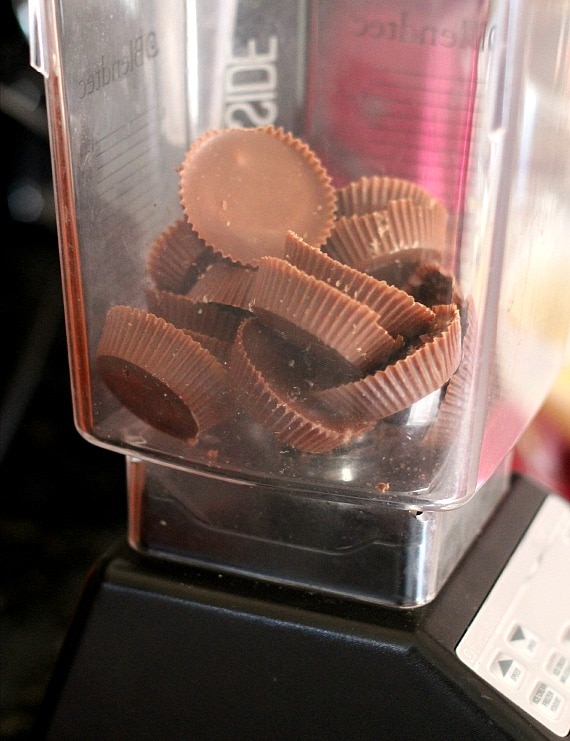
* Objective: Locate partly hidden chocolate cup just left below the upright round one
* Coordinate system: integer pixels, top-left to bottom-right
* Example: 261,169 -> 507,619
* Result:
147,219 -> 220,293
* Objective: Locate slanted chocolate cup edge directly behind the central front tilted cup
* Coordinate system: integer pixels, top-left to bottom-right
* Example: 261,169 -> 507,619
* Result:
285,232 -> 434,338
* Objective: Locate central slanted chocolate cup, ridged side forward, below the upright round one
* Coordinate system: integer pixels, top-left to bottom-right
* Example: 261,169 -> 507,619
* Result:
251,257 -> 399,372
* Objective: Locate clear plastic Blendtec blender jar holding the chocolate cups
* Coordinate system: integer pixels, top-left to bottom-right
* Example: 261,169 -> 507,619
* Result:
30,0 -> 570,607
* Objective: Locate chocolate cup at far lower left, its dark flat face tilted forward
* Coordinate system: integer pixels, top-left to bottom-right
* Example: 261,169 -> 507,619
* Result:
96,306 -> 227,443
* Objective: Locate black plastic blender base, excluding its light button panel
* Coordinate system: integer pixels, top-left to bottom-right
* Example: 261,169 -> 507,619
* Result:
36,477 -> 559,741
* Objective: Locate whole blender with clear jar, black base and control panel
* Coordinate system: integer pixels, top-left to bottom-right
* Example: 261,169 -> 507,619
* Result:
30,0 -> 570,739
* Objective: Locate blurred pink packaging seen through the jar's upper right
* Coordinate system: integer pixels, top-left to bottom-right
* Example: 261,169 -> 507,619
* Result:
306,0 -> 493,212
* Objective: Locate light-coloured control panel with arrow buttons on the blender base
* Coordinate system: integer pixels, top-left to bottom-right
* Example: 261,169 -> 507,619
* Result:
456,495 -> 570,737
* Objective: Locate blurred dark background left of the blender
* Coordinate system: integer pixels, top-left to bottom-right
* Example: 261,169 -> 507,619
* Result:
0,0 -> 126,740
